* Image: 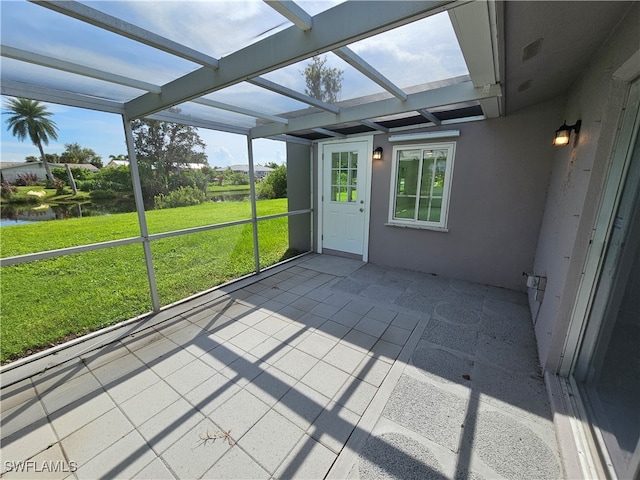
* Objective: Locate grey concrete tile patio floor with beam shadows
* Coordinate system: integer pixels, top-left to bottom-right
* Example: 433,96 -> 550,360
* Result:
1,255 -> 562,479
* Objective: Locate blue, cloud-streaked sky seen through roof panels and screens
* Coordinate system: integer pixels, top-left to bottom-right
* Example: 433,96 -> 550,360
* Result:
0,0 -> 467,166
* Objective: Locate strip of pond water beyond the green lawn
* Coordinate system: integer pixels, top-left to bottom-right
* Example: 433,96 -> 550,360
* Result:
0,193 -> 249,227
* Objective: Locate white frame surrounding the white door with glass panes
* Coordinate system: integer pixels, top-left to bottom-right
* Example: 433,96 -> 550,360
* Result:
316,135 -> 373,262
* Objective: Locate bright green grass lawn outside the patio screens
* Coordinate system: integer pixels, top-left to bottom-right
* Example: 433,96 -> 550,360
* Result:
0,199 -> 292,363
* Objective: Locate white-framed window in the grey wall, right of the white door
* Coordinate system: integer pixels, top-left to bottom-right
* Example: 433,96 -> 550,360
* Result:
389,142 -> 456,230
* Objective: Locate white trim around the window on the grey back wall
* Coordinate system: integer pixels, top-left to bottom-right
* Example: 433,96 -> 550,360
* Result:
386,142 -> 456,232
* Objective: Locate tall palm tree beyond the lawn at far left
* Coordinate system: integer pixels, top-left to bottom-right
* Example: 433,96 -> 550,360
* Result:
3,98 -> 58,182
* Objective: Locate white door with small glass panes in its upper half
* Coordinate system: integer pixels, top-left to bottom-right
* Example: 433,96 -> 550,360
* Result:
322,140 -> 372,255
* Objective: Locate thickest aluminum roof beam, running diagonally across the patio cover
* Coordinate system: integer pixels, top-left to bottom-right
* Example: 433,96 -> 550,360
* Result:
125,0 -> 457,118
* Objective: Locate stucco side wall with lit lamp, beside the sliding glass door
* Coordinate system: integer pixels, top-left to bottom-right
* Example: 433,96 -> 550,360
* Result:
530,3 -> 640,373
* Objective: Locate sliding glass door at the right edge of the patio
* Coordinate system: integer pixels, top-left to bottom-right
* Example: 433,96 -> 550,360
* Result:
573,84 -> 640,479
